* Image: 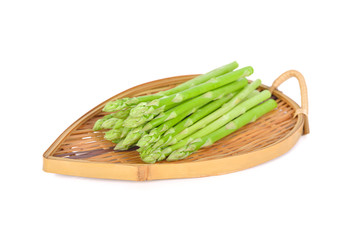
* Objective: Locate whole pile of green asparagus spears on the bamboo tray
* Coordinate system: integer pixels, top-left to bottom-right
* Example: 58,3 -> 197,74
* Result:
93,62 -> 276,163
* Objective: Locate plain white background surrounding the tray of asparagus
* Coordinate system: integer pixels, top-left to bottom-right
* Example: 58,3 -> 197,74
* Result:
0,0 -> 360,240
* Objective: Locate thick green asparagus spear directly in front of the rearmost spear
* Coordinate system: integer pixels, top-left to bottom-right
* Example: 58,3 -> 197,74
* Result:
130,66 -> 253,117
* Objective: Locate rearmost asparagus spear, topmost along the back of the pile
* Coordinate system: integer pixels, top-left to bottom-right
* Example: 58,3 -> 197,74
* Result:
103,62 -> 238,112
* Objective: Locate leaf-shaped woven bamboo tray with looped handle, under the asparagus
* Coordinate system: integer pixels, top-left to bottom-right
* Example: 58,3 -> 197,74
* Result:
43,70 -> 309,181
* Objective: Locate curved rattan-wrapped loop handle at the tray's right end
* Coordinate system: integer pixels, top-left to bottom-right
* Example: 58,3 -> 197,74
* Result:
269,70 -> 310,135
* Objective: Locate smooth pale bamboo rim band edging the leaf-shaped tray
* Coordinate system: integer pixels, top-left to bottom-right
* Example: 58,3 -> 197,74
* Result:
43,74 -> 306,181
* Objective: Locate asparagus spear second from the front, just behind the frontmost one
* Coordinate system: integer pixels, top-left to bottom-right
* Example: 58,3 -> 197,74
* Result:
144,90 -> 271,162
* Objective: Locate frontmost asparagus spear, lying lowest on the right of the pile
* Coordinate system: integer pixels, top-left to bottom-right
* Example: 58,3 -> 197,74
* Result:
166,99 -> 277,161
